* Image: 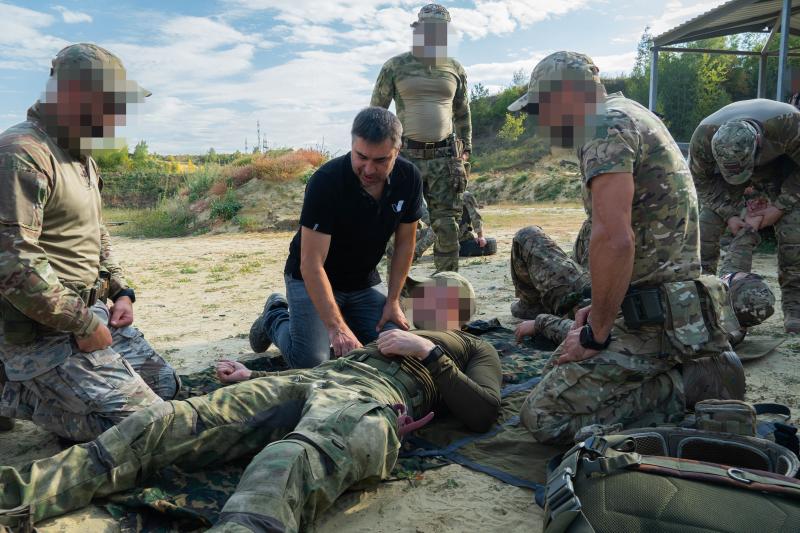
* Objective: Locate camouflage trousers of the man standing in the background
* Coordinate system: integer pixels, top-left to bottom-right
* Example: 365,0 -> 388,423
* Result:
404,155 -> 467,272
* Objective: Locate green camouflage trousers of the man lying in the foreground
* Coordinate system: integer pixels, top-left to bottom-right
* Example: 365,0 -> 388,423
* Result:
0,359 -> 407,531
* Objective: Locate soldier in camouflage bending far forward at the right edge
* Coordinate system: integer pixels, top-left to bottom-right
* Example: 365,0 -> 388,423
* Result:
689,99 -> 800,333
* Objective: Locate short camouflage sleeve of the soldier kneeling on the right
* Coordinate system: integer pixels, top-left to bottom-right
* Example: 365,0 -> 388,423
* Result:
580,110 -> 642,185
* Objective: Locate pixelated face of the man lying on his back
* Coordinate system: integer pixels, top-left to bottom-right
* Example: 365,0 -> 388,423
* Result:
408,278 -> 475,331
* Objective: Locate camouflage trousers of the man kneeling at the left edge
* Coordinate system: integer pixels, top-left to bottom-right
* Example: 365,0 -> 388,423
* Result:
0,308 -> 180,442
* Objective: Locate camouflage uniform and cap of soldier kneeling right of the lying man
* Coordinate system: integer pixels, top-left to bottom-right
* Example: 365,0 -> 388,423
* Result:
512,52 -> 730,443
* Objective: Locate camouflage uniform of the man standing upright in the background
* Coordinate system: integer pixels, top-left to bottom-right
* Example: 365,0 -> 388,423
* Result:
370,52 -> 472,271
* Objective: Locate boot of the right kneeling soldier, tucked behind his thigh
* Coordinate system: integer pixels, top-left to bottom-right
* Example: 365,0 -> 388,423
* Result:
681,352 -> 745,409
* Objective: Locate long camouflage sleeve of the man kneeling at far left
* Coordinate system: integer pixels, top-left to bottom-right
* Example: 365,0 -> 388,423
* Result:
0,156 -> 100,336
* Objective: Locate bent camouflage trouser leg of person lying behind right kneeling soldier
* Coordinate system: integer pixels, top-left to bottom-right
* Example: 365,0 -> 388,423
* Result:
511,226 -> 590,315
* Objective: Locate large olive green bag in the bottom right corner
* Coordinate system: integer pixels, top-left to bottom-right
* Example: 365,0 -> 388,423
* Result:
544,427 -> 800,533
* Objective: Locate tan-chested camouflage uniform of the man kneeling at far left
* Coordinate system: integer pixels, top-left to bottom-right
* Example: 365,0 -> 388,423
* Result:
0,45 -> 178,441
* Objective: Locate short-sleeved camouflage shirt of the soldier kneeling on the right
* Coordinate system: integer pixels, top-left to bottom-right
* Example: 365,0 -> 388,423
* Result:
577,93 -> 700,287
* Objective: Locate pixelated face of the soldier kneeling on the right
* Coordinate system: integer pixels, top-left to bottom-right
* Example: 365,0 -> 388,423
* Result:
529,79 -> 604,148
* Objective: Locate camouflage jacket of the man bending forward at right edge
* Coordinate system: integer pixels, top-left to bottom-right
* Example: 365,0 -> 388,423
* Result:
689,99 -> 800,221
